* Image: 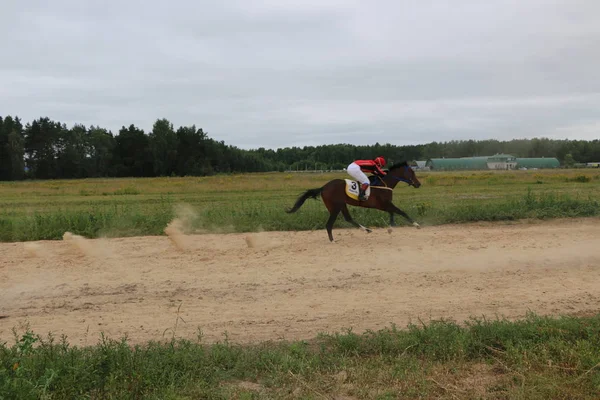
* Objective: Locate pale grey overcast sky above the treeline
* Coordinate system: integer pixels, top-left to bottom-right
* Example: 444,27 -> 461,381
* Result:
0,0 -> 600,148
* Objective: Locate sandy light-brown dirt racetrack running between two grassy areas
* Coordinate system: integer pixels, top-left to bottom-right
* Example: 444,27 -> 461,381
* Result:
0,218 -> 600,345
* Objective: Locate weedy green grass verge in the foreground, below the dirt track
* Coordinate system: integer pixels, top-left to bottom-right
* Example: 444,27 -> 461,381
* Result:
0,314 -> 600,400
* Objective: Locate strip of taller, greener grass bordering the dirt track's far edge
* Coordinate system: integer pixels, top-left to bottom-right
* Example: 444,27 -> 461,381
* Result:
0,191 -> 600,242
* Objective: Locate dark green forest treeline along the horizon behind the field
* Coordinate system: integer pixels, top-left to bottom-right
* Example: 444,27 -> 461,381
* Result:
0,116 -> 600,180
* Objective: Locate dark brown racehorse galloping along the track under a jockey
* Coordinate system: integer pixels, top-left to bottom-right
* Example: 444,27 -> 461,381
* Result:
286,161 -> 421,241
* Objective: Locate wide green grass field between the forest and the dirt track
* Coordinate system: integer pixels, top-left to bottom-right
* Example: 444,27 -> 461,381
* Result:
0,169 -> 600,241
